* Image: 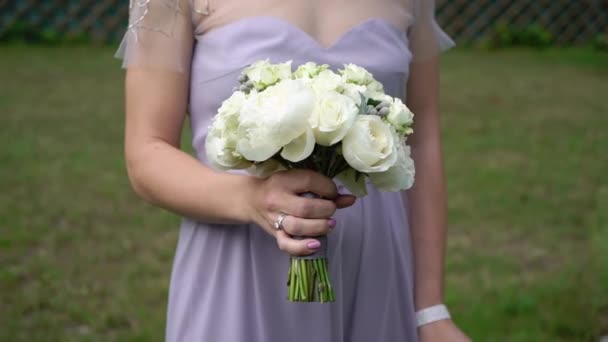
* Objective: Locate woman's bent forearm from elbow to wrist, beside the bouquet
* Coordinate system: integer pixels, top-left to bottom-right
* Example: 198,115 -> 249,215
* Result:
127,140 -> 256,223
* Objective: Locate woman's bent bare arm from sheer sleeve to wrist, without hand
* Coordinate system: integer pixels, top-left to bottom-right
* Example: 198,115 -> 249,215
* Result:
125,68 -> 255,223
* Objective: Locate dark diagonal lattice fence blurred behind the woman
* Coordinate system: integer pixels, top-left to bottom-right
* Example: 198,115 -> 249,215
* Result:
0,0 -> 608,44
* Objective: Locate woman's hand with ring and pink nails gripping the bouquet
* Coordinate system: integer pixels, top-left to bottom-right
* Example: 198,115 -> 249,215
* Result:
249,170 -> 356,256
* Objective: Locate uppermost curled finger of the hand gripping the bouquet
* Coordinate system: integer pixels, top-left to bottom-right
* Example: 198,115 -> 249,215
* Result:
282,169 -> 338,199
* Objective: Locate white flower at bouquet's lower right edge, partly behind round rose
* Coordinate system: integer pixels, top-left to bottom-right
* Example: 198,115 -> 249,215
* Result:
369,145 -> 416,191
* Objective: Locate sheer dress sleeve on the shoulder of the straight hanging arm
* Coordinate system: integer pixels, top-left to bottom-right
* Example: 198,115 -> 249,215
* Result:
408,0 -> 455,63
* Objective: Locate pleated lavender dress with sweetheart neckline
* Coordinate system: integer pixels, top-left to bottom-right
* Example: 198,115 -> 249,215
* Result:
117,1 -> 449,342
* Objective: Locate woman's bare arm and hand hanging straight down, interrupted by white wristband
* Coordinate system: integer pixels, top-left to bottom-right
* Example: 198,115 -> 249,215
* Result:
404,57 -> 468,341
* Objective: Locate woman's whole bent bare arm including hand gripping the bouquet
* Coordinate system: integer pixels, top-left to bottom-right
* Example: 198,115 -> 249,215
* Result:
125,67 -> 354,255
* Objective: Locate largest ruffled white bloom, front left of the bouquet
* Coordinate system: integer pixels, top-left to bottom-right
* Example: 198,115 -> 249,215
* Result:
237,79 -> 315,161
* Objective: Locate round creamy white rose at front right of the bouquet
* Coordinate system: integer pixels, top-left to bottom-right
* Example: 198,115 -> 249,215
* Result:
342,115 -> 399,173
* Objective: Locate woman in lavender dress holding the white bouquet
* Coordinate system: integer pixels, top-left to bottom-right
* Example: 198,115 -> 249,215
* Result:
121,0 -> 468,342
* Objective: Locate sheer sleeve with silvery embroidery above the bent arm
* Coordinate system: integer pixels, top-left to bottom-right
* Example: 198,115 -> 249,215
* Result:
116,0 -> 194,75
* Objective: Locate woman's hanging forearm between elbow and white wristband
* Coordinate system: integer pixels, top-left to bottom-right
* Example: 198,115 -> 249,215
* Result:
407,137 -> 447,310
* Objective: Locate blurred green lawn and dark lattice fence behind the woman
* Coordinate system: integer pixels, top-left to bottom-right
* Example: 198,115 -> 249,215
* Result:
0,0 -> 608,341
